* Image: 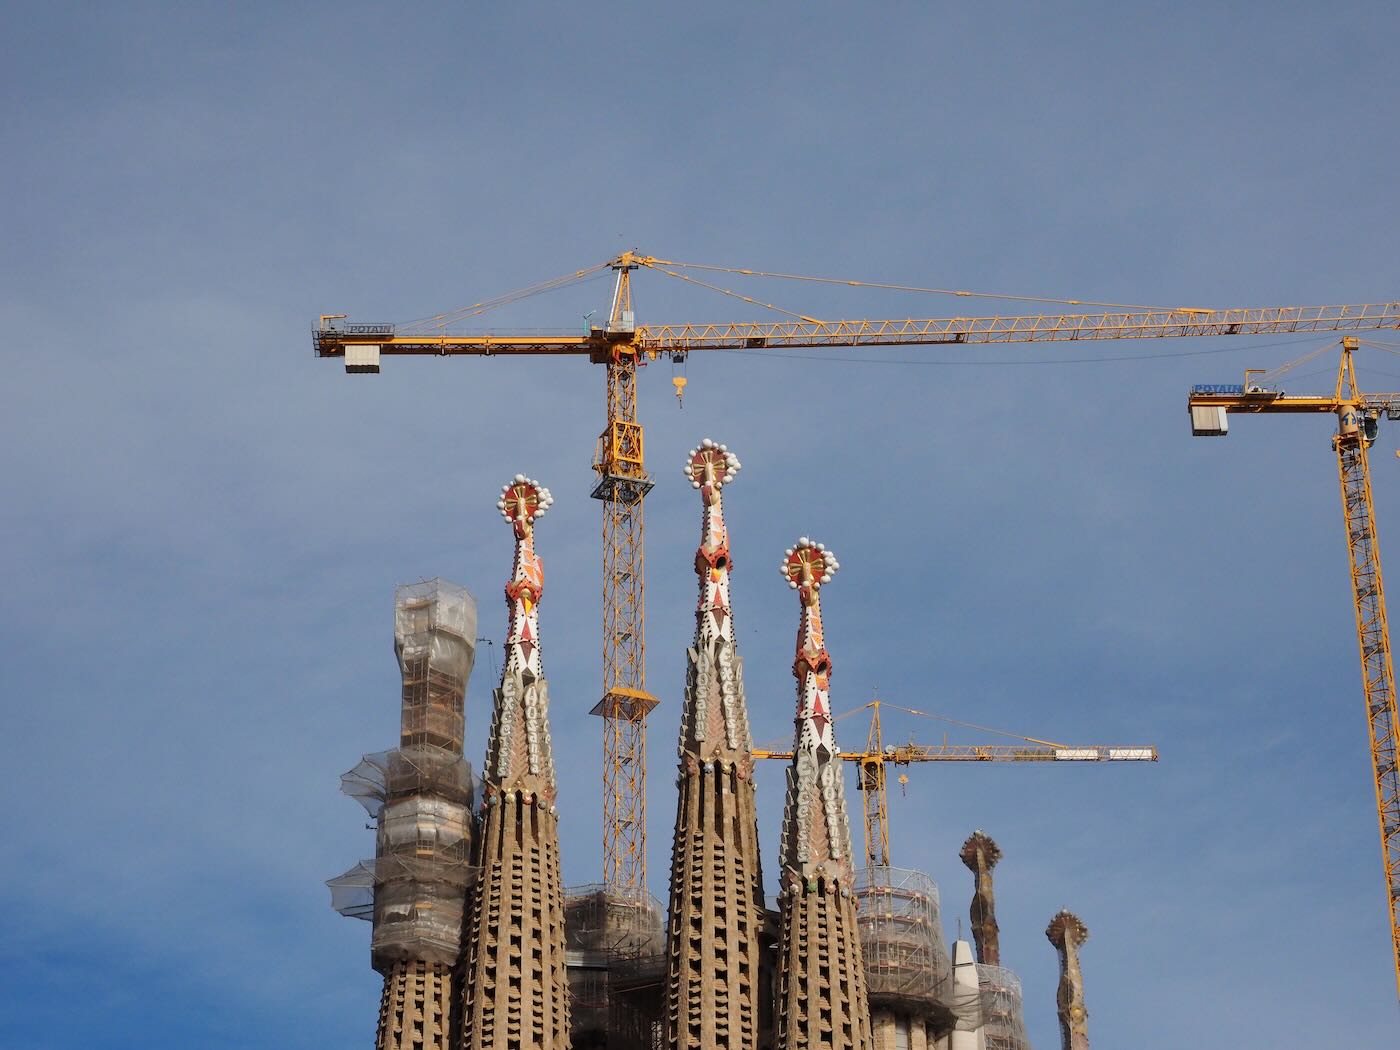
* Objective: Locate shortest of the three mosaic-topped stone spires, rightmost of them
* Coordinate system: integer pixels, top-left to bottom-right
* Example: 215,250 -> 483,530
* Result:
777,536 -> 871,1050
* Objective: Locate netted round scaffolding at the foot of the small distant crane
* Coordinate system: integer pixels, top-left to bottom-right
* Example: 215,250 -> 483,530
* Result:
855,867 -> 952,1009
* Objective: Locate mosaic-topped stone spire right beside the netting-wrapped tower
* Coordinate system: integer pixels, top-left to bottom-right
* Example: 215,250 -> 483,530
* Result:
461,475 -> 568,1050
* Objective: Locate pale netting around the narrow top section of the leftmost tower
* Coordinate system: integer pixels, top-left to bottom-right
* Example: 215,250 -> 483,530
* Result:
393,580 -> 476,755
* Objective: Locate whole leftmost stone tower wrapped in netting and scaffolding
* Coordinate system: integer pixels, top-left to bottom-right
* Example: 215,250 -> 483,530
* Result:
328,580 -> 476,1050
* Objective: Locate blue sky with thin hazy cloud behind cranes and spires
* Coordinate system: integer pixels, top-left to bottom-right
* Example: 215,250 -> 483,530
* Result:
8,3 -> 1400,1050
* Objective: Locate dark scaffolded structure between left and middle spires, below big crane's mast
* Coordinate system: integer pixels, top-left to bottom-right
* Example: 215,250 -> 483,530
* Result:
564,883 -> 666,1050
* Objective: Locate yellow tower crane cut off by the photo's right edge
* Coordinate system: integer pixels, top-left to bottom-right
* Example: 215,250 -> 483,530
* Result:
1187,336 -> 1400,994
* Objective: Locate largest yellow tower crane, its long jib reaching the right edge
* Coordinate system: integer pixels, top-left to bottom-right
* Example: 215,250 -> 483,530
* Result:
312,252 -> 1400,896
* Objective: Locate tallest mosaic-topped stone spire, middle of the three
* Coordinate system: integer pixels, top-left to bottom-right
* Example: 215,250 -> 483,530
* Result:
666,438 -> 763,1050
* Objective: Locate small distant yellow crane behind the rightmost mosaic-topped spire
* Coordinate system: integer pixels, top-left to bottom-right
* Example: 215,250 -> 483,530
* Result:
753,700 -> 1156,868
